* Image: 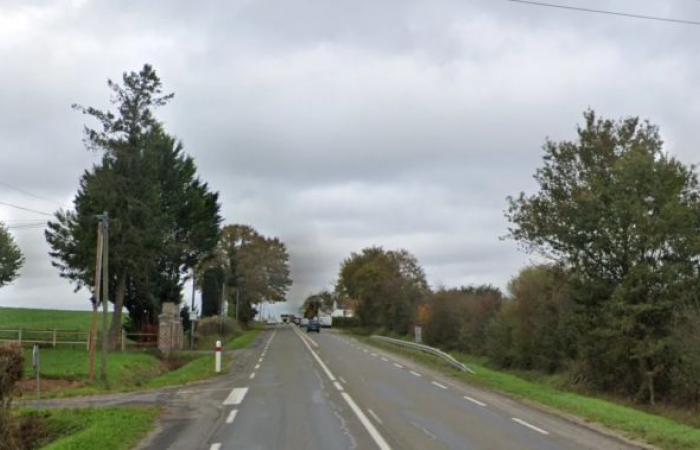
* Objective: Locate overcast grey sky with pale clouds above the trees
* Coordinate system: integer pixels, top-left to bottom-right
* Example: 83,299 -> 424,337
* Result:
0,0 -> 700,316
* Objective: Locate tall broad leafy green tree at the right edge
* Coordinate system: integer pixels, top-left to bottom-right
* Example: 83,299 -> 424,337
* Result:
507,111 -> 700,403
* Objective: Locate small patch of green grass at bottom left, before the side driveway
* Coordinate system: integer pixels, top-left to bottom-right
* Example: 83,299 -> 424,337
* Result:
42,408 -> 159,450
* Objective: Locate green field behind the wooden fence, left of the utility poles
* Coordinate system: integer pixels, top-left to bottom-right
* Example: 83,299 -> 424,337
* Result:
0,308 -> 92,331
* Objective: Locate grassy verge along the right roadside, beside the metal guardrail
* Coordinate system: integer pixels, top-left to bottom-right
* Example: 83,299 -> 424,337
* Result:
363,338 -> 700,450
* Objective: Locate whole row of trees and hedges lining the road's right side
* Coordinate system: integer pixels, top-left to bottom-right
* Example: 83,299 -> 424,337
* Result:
328,110 -> 700,404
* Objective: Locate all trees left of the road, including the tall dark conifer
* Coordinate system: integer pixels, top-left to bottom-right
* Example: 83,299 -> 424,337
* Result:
0,64 -> 291,347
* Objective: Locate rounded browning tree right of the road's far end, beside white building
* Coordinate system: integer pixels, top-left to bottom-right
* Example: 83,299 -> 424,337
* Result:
336,247 -> 429,334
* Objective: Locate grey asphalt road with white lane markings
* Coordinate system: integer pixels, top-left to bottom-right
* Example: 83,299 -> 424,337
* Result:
187,326 -> 638,450
